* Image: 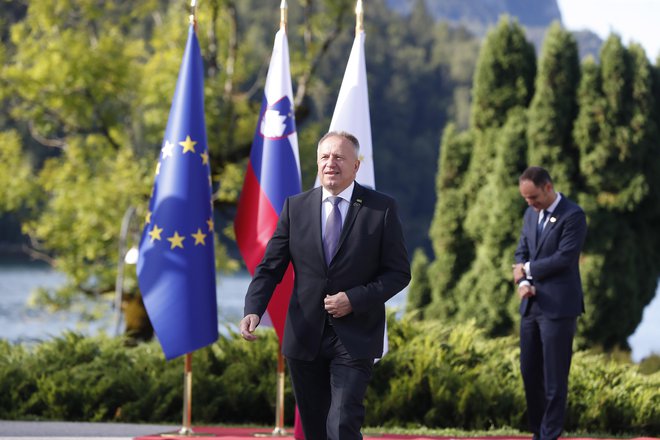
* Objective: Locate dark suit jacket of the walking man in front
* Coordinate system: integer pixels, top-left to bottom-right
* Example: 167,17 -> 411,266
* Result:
244,183 -> 410,360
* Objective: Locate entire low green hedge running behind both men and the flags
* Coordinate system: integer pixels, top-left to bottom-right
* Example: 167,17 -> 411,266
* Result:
0,319 -> 660,436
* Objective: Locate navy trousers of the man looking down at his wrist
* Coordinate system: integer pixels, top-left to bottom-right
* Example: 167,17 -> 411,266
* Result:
520,300 -> 576,440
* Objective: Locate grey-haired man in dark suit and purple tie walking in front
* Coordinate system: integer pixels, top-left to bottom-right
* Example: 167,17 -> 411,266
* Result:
240,132 -> 410,440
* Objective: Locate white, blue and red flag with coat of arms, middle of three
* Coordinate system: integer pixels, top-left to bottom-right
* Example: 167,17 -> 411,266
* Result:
234,29 -> 302,342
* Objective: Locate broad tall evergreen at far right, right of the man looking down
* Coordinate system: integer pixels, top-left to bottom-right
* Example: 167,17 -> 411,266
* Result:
575,36 -> 660,348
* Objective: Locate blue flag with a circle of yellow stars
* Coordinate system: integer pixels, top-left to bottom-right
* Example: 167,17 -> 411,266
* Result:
137,25 -> 218,360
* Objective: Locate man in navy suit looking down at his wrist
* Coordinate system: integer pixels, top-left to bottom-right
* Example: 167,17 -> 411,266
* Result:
513,167 -> 587,440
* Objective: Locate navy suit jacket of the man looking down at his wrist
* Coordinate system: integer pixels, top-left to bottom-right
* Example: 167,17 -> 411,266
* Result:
515,196 -> 587,318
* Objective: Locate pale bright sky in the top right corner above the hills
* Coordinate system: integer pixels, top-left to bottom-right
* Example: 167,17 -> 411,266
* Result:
558,0 -> 660,62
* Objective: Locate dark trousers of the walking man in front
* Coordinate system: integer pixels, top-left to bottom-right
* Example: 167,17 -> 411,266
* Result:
287,325 -> 374,440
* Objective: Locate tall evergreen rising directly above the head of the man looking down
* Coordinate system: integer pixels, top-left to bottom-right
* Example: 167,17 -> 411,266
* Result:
527,22 -> 580,197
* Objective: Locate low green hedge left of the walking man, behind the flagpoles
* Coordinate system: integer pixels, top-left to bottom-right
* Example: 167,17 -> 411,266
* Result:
0,332 -> 293,424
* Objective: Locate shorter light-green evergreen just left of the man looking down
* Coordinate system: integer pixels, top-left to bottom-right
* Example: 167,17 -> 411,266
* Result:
455,107 -> 527,335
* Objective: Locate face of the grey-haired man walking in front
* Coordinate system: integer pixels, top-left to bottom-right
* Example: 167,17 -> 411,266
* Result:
316,136 -> 360,195
